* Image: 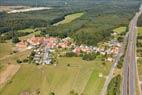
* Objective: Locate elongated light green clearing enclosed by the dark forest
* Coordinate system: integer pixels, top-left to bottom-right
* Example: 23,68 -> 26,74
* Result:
54,13 -> 84,25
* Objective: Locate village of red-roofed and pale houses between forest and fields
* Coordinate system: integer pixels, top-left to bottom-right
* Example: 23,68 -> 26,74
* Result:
15,33 -> 121,64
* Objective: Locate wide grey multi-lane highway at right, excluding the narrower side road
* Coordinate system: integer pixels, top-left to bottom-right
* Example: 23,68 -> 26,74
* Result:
121,4 -> 142,95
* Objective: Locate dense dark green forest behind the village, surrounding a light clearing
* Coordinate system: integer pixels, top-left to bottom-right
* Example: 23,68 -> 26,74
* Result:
0,1 -> 139,45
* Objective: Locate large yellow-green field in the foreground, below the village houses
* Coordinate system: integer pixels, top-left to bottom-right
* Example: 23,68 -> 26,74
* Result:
0,57 -> 111,95
